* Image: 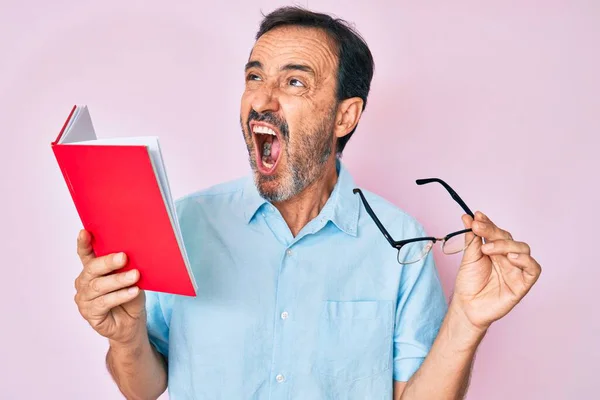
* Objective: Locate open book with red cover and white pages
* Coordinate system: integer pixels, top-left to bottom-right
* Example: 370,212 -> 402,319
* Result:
52,106 -> 197,296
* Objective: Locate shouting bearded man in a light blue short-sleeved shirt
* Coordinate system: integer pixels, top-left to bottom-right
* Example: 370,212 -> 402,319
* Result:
75,8 -> 541,400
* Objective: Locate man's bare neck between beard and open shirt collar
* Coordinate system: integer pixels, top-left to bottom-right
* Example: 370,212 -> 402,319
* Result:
273,155 -> 338,237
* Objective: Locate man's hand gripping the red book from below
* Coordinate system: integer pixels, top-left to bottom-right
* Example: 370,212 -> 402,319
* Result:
75,230 -> 146,345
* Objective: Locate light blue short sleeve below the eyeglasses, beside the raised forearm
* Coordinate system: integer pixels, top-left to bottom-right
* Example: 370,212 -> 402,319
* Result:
393,223 -> 448,382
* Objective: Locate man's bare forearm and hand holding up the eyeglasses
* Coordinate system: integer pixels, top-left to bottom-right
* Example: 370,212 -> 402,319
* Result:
394,212 -> 541,400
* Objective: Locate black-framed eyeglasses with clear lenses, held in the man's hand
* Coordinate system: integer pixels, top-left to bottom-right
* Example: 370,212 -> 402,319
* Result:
353,178 -> 475,265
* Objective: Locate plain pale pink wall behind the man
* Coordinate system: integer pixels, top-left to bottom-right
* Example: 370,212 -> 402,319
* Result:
0,0 -> 600,400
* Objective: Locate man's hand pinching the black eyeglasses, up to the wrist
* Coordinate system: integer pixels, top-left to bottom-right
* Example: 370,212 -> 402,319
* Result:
452,212 -> 542,332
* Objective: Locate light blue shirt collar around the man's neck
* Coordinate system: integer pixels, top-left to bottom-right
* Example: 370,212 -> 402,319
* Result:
243,159 -> 360,236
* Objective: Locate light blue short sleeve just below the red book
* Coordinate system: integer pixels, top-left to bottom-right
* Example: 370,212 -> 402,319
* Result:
145,291 -> 172,358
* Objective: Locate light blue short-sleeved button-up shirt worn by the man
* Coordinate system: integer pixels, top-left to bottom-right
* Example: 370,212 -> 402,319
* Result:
146,161 -> 447,400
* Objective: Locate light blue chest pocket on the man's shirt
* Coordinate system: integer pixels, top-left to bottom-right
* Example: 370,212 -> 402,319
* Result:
314,301 -> 393,383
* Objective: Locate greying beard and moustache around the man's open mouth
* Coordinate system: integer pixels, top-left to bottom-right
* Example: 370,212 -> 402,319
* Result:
240,108 -> 335,202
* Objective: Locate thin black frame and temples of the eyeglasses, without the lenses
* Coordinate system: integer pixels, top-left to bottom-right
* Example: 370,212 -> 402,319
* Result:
352,178 -> 475,264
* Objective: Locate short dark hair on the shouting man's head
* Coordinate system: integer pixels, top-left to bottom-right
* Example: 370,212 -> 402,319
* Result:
256,7 -> 375,155
